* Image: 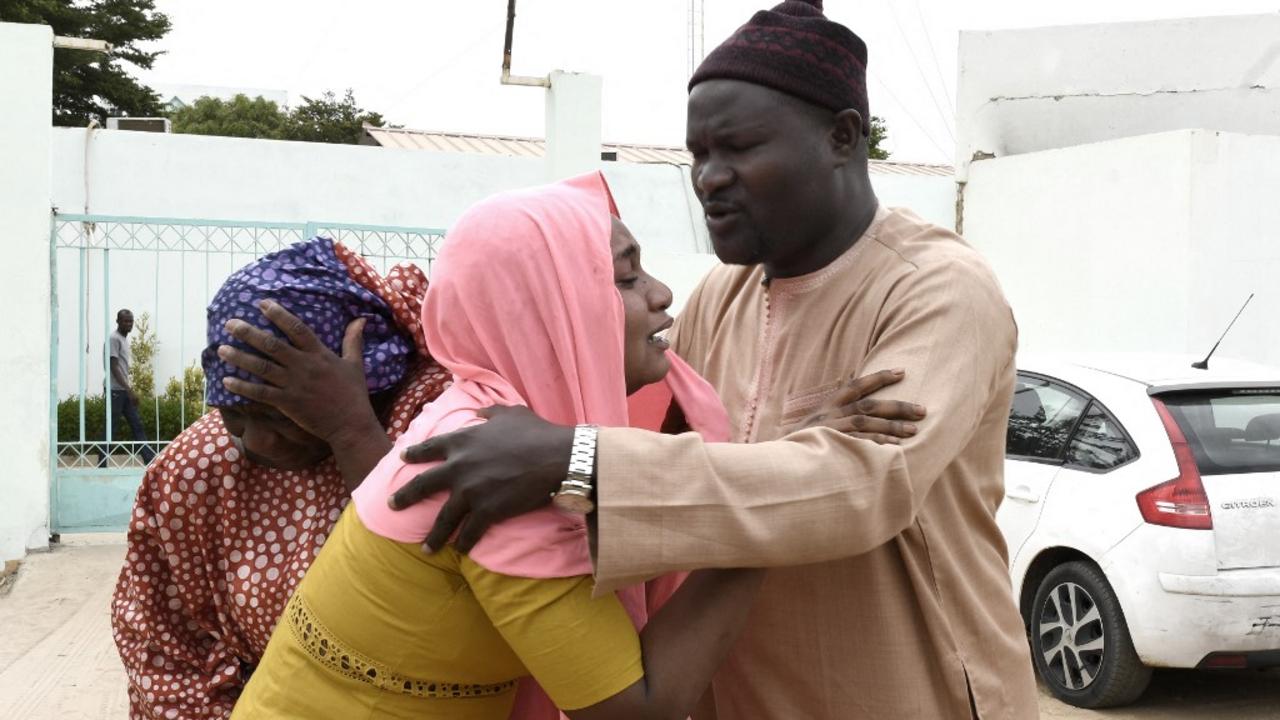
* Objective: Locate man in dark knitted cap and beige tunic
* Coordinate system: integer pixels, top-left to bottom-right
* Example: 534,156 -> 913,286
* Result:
397,0 -> 1037,720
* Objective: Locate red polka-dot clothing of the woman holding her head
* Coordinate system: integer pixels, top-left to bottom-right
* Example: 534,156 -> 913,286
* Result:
111,251 -> 449,720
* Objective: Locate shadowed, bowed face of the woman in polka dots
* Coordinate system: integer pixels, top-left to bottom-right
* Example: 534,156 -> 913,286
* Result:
218,402 -> 332,470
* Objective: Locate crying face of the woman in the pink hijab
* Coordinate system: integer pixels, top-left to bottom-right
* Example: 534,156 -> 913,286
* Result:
609,218 -> 672,395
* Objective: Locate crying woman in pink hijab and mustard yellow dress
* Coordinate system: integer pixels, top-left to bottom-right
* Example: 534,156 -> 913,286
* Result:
232,173 -> 762,720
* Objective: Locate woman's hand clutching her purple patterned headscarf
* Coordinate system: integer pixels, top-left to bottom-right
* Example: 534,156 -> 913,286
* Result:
218,300 -> 380,445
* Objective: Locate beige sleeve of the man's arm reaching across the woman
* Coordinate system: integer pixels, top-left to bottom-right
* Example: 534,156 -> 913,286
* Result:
586,260 -> 1016,589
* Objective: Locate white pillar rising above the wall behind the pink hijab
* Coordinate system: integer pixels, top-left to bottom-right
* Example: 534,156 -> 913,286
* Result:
547,70 -> 604,181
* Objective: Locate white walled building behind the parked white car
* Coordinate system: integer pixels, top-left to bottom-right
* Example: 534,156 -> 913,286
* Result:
956,14 -> 1280,365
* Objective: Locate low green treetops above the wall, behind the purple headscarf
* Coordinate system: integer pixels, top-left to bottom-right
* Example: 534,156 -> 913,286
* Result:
169,90 -> 383,145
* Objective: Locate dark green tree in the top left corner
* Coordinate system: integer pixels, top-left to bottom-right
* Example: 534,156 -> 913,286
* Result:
0,0 -> 170,126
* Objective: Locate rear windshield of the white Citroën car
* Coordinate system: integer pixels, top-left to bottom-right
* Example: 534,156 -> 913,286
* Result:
1160,388 -> 1280,475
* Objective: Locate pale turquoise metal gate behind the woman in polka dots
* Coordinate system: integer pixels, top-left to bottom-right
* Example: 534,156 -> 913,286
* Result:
50,214 -> 444,533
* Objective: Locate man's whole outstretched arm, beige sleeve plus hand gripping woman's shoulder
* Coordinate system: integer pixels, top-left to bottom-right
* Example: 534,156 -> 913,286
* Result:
392,265 -> 1016,588
